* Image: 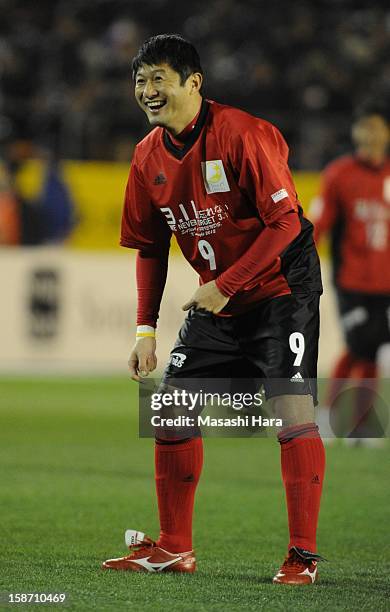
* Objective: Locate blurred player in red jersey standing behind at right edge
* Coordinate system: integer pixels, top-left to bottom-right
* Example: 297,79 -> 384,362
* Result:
313,102 -> 390,444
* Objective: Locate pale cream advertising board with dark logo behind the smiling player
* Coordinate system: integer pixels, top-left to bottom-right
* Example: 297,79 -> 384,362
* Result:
0,247 -> 341,375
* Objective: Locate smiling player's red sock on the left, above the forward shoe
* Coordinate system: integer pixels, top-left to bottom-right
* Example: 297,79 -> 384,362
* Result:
155,438 -> 203,553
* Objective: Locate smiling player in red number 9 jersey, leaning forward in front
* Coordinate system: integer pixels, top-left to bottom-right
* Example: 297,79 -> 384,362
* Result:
103,35 -> 325,584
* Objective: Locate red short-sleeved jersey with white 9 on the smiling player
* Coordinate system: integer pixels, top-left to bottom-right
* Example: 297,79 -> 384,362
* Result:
121,101 -> 321,314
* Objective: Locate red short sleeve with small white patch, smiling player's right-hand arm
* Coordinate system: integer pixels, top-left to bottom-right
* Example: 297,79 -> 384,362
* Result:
232,120 -> 298,225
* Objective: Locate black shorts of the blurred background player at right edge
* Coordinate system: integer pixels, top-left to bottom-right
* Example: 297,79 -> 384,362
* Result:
337,289 -> 390,361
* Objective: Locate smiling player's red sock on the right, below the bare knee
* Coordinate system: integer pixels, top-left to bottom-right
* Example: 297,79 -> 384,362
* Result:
278,423 -> 325,552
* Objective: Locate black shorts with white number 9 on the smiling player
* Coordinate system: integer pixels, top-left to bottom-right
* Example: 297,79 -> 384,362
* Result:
162,292 -> 320,404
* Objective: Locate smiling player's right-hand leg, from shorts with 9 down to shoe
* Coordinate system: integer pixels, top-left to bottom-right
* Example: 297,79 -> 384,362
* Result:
240,294 -> 325,584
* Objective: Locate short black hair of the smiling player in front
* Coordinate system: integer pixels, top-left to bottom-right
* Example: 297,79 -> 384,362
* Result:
132,34 -> 203,85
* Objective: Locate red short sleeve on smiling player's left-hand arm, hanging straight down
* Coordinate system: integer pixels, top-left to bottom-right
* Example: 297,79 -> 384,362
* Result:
120,161 -> 171,251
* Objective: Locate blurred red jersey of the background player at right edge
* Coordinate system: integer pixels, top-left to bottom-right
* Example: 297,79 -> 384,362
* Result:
315,156 -> 390,294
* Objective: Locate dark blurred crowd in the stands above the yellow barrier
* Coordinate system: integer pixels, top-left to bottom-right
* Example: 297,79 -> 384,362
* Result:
0,0 -> 390,170
